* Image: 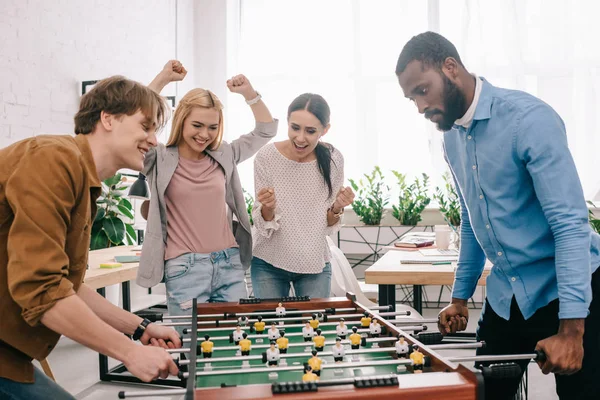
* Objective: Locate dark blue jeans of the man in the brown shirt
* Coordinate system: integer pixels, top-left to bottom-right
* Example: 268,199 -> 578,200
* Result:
0,368 -> 75,400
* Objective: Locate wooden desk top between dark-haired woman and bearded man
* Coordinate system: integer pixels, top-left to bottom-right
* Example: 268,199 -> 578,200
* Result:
365,251 -> 492,286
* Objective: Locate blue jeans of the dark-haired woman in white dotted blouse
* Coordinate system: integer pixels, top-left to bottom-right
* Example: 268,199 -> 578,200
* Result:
250,257 -> 331,299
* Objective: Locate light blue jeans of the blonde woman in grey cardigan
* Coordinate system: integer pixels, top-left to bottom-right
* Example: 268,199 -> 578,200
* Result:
165,247 -> 248,333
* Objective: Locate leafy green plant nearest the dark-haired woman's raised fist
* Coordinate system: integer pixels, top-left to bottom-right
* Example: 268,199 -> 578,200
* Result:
349,166 -> 390,225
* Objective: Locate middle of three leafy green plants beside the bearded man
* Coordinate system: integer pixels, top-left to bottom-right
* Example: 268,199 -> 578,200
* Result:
392,171 -> 431,226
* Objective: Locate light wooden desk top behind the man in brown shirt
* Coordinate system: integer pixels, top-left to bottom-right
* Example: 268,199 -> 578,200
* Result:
83,246 -> 140,289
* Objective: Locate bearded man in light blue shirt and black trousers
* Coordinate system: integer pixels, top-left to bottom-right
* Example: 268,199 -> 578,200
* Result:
396,32 -> 600,399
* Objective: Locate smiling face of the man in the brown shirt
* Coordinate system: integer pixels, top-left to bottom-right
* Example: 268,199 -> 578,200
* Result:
102,110 -> 156,171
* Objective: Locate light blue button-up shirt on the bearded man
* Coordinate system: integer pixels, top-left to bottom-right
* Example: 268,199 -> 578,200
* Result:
444,79 -> 600,319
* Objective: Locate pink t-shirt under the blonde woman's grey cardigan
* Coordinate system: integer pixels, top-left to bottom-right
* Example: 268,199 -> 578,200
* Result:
165,156 -> 238,260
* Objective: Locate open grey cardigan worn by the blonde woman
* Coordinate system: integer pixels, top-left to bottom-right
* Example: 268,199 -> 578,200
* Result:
136,120 -> 278,288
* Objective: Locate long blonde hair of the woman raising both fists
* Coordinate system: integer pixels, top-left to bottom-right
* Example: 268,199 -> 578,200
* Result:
167,89 -> 223,150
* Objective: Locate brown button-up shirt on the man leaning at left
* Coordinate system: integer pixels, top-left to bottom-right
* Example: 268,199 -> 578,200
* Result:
0,135 -> 101,382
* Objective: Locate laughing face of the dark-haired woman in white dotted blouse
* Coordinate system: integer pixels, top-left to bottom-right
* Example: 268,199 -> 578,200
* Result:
288,110 -> 329,158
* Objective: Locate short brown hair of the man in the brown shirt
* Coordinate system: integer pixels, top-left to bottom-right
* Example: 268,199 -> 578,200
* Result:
74,75 -> 169,135
